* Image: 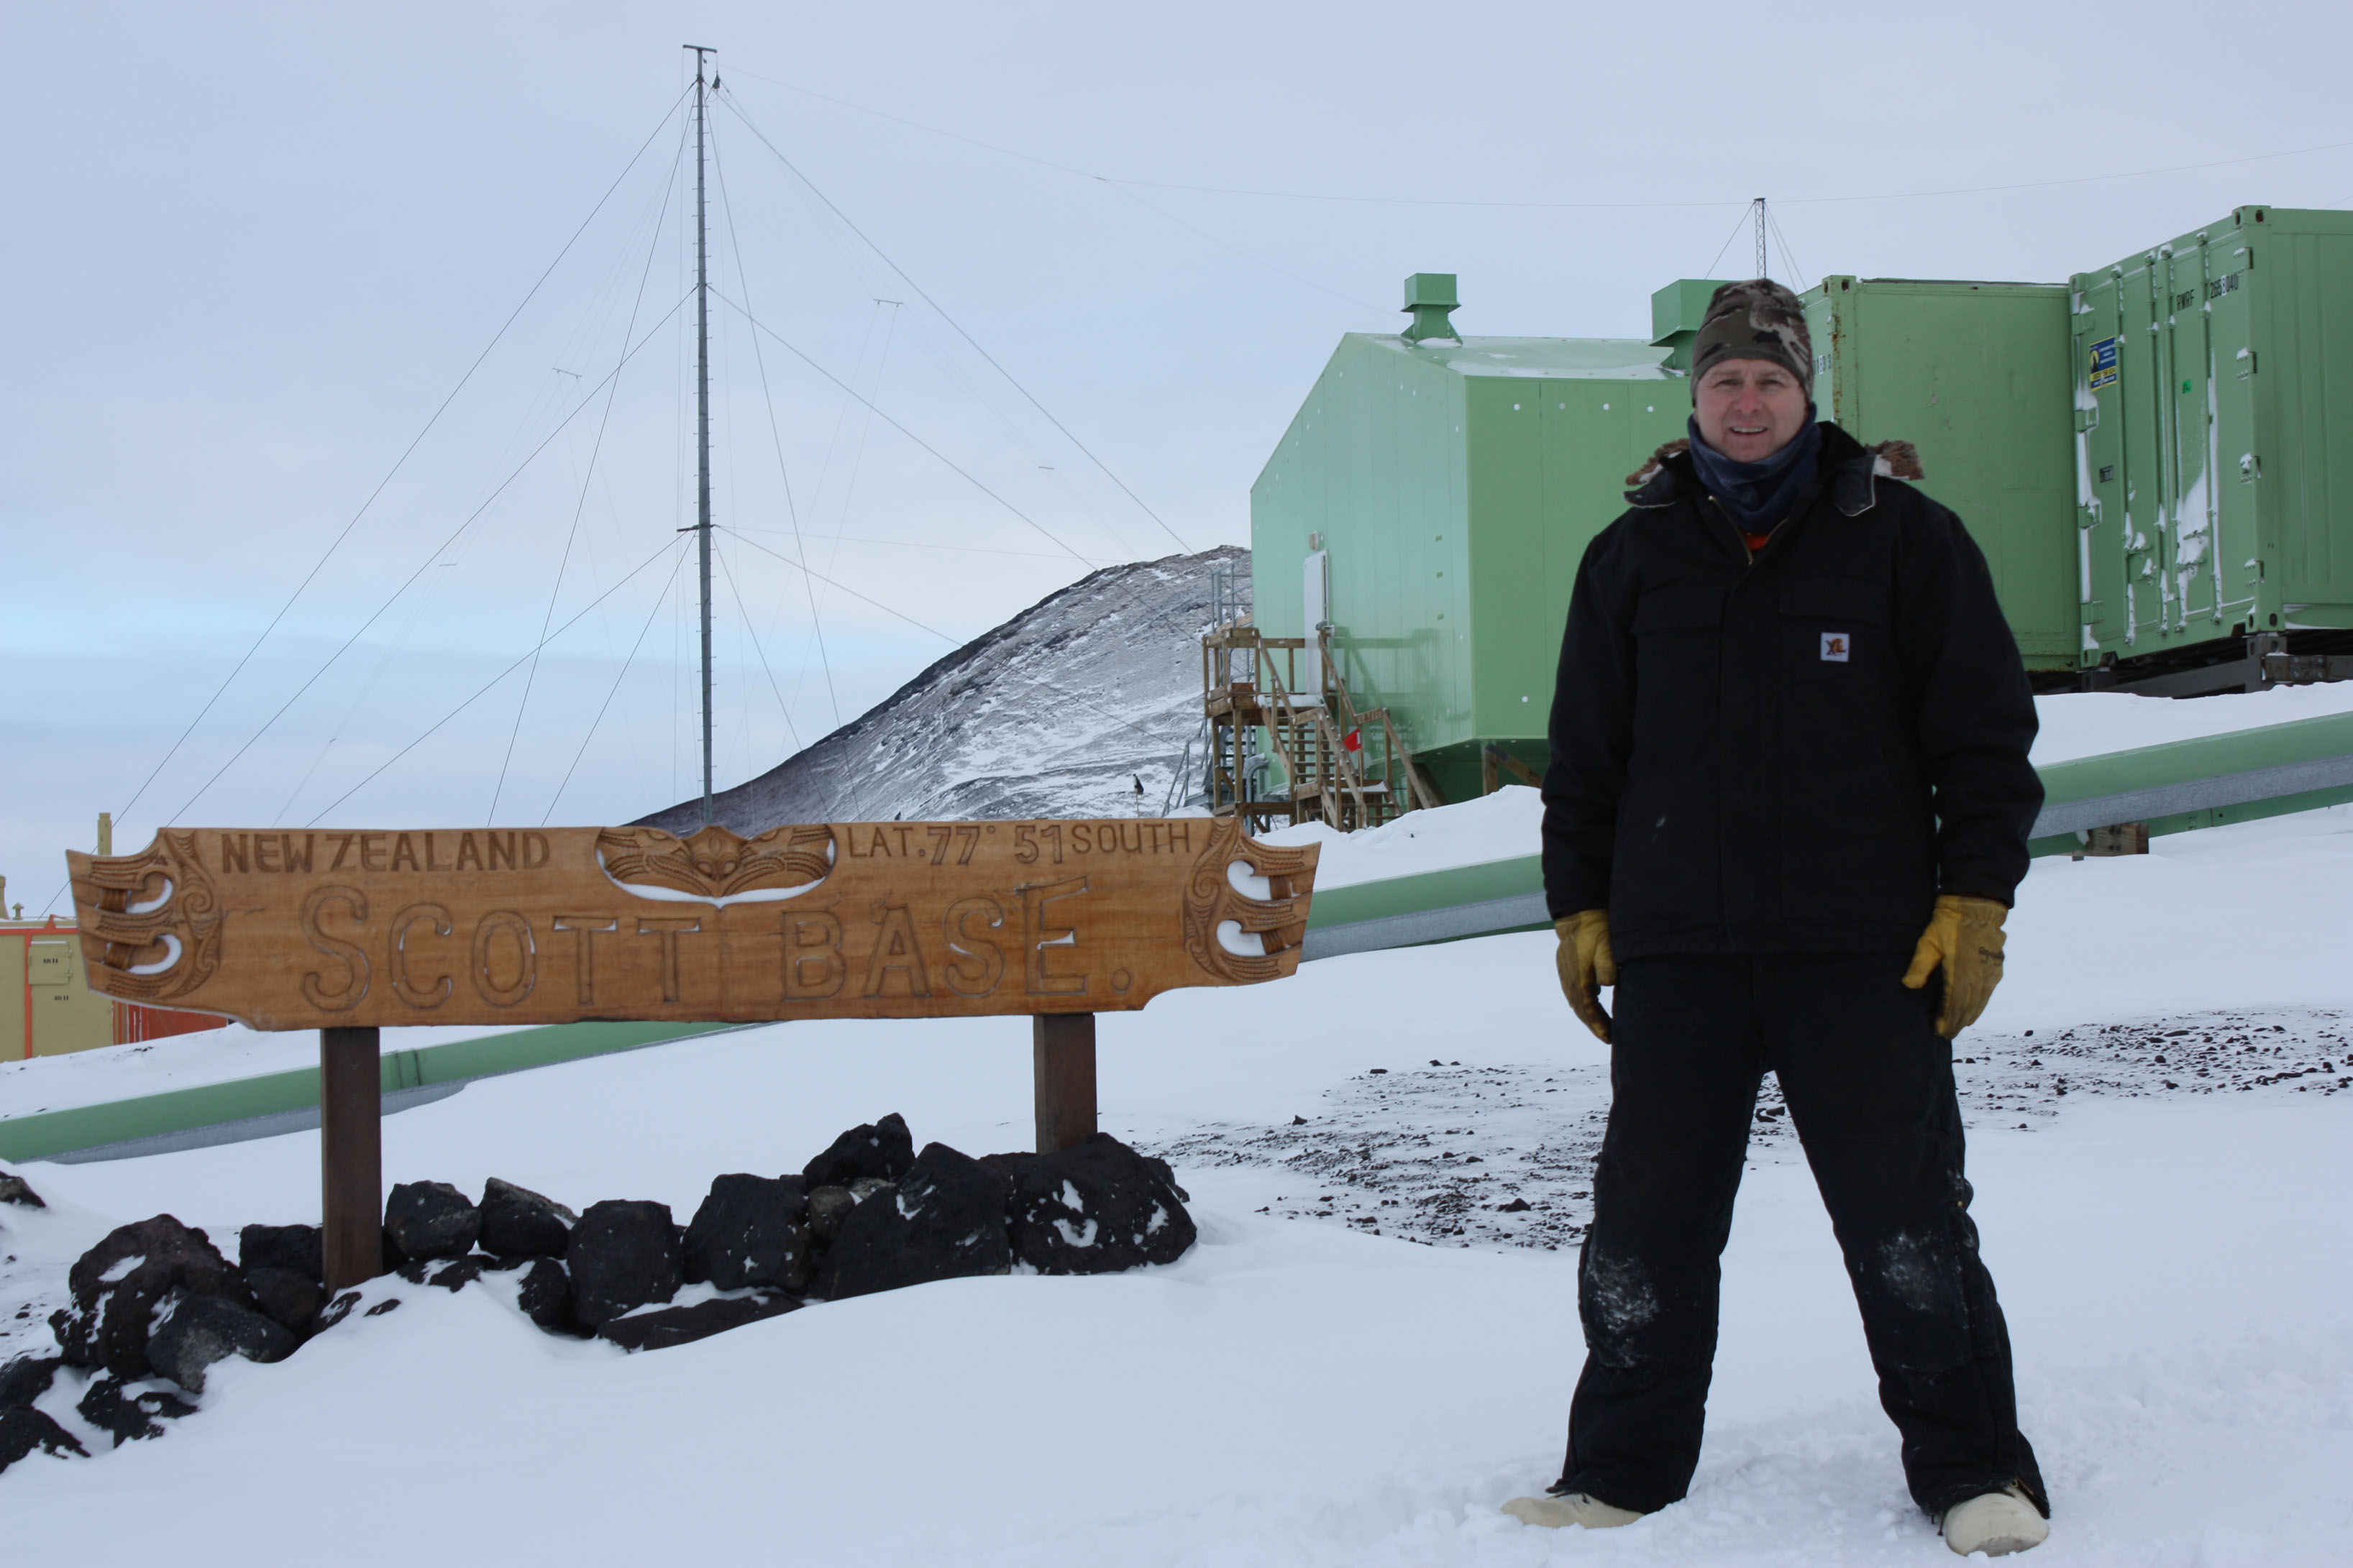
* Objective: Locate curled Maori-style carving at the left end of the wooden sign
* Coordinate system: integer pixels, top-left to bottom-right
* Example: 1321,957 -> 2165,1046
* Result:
73,833 -> 221,1001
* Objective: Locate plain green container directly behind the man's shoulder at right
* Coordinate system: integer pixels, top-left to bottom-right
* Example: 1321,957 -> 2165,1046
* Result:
1805,278 -> 2083,670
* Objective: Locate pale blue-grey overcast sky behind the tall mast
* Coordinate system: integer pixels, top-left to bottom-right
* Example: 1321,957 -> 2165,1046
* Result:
0,0 -> 2353,912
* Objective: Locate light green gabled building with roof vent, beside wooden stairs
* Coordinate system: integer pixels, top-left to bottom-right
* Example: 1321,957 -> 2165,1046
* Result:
1249,272 -> 1713,799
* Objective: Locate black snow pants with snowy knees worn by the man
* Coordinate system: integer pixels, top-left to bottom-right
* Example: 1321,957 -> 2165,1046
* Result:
1553,952 -> 2050,1516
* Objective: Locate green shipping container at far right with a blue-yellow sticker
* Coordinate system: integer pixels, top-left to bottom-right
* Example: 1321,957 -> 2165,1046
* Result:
2070,207 -> 2353,663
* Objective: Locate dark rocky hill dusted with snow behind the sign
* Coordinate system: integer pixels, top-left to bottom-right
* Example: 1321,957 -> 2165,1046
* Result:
640,546 -> 1249,835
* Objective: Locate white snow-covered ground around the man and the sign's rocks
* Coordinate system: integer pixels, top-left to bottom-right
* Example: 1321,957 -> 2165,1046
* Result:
14,694 -> 2353,1568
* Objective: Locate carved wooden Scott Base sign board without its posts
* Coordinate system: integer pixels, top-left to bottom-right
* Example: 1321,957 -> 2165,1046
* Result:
66,818 -> 1315,1030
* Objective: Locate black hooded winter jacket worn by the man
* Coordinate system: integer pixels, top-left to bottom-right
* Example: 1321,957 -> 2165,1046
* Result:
1543,423 -> 2042,959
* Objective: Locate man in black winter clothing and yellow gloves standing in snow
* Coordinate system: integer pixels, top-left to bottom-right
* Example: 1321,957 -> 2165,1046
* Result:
1506,280 -> 2050,1554
